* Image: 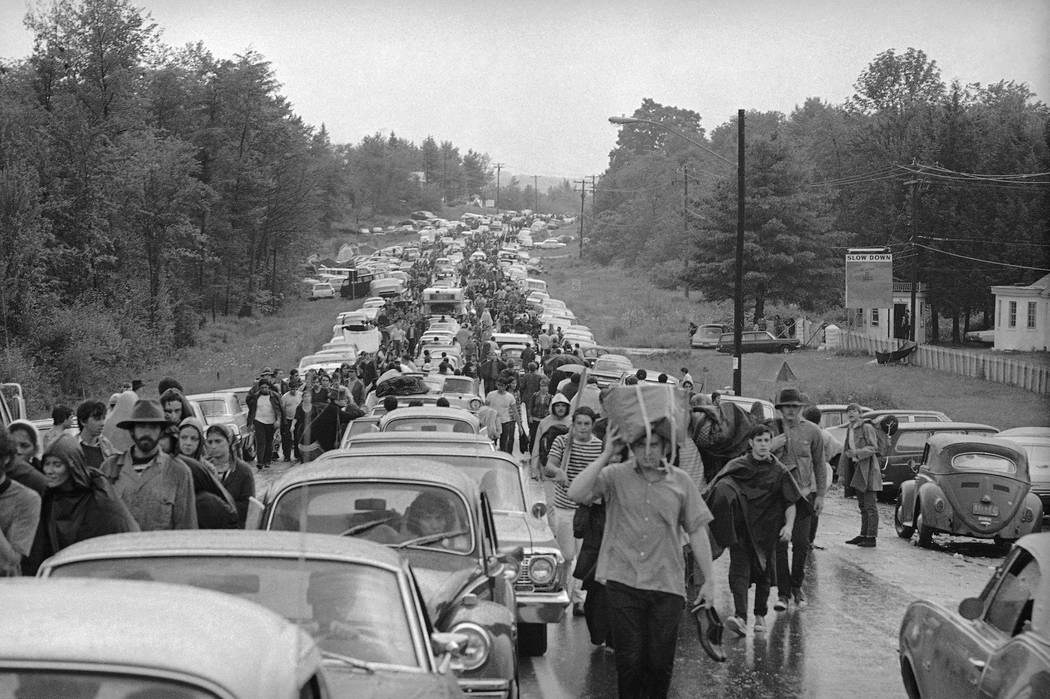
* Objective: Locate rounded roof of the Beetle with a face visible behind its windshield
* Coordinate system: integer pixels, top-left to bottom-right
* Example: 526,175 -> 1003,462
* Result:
270,449 -> 478,496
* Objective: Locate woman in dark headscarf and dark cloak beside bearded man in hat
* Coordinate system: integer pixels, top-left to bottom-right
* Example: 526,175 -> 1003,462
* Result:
28,435 -> 139,573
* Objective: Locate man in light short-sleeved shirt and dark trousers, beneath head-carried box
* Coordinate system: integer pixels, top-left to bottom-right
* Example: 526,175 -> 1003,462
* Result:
567,419 -> 716,699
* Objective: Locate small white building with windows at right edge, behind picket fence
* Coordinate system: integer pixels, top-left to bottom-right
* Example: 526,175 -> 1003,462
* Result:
991,274 -> 1050,352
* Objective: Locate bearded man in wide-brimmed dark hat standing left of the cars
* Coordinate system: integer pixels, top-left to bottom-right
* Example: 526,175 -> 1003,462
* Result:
100,399 -> 197,531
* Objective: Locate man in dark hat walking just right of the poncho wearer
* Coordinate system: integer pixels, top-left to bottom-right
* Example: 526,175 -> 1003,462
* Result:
771,388 -> 827,612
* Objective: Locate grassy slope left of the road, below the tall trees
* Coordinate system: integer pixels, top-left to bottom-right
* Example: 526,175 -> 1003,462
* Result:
142,291 -> 352,394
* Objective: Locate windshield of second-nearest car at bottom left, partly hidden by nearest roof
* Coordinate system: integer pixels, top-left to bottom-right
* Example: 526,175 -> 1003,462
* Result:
48,555 -> 423,663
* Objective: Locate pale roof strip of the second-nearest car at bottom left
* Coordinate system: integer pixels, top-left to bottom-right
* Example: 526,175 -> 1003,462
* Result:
38,529 -> 401,569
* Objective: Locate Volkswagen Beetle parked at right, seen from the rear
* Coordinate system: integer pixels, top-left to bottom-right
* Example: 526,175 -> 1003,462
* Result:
894,435 -> 1043,547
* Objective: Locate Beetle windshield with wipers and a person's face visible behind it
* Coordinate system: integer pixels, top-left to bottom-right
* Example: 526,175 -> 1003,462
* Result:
270,481 -> 474,553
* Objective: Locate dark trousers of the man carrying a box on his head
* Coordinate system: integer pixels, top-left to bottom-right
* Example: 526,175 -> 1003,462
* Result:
606,580 -> 686,699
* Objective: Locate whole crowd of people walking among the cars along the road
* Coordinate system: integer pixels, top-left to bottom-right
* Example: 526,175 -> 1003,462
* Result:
0,221 -> 879,697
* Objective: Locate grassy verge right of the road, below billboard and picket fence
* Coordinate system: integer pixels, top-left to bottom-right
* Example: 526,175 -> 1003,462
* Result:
545,250 -> 1050,429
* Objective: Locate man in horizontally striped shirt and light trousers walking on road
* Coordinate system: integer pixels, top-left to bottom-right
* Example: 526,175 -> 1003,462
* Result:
545,406 -> 603,616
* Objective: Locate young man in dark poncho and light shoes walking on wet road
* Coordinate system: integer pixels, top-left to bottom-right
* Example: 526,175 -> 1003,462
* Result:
706,425 -> 805,636
